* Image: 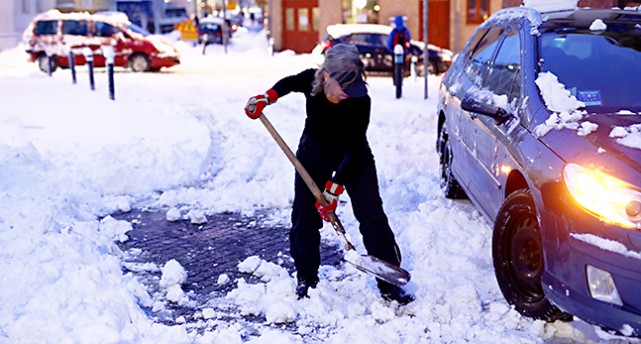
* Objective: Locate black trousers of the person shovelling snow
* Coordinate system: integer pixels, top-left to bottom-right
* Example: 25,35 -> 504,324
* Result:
289,134 -> 401,289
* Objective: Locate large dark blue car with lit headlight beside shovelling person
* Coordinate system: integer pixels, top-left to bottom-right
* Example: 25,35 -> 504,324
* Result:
436,1 -> 641,336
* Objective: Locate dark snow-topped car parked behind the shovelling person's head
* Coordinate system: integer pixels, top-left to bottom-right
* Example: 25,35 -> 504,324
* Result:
312,24 -> 454,75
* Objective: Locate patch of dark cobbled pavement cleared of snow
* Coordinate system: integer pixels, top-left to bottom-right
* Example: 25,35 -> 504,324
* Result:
112,209 -> 342,323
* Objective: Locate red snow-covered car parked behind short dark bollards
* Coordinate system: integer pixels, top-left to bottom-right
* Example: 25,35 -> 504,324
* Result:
22,10 -> 180,72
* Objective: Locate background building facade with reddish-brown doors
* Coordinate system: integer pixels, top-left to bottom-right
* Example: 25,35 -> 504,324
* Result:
266,0 -> 640,53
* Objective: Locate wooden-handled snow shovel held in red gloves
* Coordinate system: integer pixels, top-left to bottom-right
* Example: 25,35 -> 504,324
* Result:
259,114 -> 410,287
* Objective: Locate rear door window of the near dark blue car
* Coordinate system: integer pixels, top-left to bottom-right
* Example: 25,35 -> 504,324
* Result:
465,28 -> 505,86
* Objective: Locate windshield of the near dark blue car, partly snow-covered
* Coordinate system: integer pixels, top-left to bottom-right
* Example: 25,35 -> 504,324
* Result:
539,25 -> 641,113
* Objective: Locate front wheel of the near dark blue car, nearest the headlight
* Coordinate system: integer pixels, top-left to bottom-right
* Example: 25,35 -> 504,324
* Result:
492,189 -> 572,322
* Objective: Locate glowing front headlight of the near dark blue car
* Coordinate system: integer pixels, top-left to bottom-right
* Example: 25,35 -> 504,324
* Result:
563,163 -> 641,228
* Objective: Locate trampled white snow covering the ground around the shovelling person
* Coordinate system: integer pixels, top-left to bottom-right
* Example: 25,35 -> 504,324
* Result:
0,24 -> 639,343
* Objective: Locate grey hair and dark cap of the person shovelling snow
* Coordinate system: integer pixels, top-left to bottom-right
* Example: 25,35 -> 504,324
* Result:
312,43 -> 365,96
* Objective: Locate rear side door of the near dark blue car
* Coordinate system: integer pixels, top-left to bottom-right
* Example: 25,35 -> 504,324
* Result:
460,27 -> 505,215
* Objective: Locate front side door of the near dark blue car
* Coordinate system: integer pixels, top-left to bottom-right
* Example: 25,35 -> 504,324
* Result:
469,29 -> 521,218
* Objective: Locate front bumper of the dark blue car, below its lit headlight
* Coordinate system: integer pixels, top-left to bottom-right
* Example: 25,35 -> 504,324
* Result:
541,196 -> 641,336
